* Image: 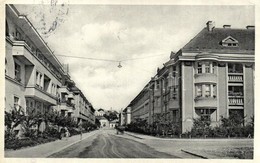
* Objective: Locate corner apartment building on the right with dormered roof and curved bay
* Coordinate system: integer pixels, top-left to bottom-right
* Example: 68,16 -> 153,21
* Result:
125,21 -> 255,132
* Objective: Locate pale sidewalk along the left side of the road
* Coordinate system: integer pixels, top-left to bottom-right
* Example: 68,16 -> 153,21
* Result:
5,130 -> 98,158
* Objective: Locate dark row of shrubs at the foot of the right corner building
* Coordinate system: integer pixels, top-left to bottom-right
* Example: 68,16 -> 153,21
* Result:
126,114 -> 254,138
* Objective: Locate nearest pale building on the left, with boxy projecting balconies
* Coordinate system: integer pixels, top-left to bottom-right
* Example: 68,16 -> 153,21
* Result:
5,5 -> 64,116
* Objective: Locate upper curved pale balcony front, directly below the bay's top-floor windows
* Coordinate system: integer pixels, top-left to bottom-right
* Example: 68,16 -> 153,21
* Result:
194,73 -> 218,83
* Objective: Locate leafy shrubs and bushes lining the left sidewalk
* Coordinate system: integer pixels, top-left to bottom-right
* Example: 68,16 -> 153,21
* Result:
5,107 -> 97,149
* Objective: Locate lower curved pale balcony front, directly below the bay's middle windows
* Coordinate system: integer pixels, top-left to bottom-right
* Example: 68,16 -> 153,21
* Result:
194,97 -> 217,108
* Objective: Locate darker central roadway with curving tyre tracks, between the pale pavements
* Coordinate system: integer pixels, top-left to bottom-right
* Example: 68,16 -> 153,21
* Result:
49,130 -> 178,158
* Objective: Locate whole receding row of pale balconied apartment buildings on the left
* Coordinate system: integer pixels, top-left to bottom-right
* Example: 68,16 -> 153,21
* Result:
5,5 -> 95,128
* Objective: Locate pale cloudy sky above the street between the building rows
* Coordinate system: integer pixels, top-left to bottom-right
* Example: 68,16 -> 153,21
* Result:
15,3 -> 255,110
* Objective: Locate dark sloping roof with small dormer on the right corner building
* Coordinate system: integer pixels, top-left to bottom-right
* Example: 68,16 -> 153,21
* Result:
182,28 -> 255,53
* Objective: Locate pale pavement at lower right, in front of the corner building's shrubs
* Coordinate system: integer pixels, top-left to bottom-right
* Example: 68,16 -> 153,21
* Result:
125,132 -> 254,159
